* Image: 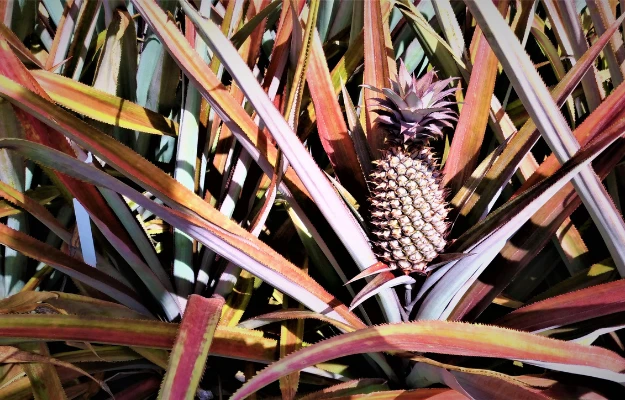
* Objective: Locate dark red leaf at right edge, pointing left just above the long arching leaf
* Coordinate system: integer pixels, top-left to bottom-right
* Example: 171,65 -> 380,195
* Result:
495,279 -> 625,332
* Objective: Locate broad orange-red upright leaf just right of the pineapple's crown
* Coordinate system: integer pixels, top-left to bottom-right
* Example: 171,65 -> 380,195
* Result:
443,0 -> 508,193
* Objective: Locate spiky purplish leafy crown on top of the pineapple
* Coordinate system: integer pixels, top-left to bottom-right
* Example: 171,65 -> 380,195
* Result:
364,61 -> 457,144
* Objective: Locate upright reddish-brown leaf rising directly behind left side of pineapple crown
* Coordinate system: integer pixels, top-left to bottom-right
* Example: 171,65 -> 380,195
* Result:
363,0 -> 392,159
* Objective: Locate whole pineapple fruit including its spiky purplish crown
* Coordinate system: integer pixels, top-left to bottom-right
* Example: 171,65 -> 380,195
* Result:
367,63 -> 456,274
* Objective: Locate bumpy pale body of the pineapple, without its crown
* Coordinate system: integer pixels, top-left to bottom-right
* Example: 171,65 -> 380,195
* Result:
370,146 -> 449,274
